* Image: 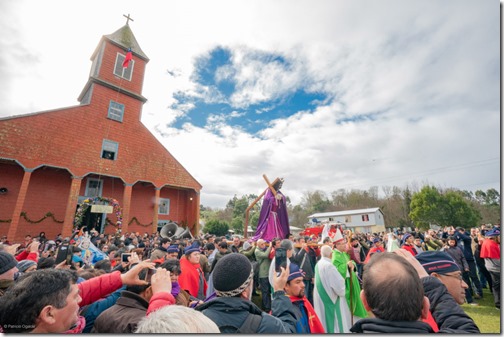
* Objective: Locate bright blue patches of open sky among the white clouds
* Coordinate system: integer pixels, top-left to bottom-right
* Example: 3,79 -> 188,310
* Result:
171,47 -> 328,134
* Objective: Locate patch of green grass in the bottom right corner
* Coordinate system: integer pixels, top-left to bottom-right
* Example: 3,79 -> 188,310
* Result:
462,288 -> 501,334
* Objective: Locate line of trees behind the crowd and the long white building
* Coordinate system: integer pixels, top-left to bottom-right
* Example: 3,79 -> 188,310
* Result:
200,185 -> 500,235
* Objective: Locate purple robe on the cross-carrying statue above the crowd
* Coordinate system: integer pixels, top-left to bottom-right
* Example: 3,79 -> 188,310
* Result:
251,188 -> 290,241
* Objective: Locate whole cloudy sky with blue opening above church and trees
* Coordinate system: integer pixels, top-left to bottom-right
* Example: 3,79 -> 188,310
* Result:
0,0 -> 500,207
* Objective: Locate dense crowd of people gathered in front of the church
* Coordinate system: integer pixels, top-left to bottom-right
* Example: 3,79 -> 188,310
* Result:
0,220 -> 500,333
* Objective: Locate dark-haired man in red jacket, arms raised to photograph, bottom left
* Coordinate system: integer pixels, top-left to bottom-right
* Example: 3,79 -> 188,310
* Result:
0,261 -> 175,334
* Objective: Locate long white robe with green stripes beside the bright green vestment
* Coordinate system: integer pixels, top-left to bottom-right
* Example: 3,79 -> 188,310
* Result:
313,257 -> 352,333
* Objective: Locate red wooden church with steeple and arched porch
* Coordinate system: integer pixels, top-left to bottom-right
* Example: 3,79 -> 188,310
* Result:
0,23 -> 202,242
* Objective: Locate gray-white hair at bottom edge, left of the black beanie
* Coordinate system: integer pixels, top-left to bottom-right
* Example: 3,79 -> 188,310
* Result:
135,305 -> 220,334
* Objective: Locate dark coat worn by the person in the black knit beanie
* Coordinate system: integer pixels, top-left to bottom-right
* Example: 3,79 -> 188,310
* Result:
196,292 -> 297,334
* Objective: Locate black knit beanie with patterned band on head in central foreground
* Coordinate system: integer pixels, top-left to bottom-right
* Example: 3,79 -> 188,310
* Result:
212,253 -> 254,297
